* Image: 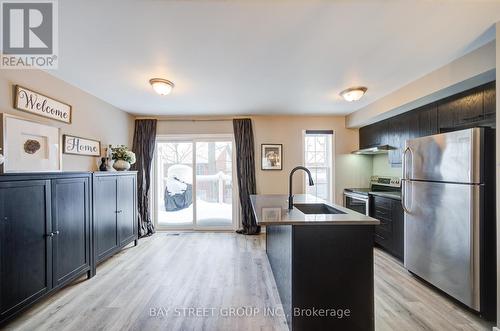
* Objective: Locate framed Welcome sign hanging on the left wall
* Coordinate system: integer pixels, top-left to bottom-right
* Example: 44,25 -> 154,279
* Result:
14,85 -> 71,124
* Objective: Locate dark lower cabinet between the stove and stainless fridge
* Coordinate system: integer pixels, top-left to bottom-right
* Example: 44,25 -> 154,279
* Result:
370,195 -> 404,261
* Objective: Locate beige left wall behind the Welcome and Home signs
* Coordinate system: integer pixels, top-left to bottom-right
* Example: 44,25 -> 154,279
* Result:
0,70 -> 134,171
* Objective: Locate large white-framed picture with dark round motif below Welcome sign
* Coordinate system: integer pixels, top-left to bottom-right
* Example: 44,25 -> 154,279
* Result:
0,114 -> 62,173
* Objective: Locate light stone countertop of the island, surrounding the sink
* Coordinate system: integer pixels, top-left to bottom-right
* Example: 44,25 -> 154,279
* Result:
250,194 -> 380,225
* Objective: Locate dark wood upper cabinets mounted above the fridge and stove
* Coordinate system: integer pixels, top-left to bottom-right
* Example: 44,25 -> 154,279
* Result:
359,82 -> 496,166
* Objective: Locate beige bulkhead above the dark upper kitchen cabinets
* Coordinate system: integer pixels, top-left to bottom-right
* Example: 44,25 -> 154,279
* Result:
346,41 -> 496,128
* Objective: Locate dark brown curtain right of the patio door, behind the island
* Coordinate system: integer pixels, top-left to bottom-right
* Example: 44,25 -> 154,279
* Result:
233,118 -> 260,234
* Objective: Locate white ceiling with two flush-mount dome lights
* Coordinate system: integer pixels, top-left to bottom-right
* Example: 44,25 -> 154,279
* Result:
51,0 -> 500,115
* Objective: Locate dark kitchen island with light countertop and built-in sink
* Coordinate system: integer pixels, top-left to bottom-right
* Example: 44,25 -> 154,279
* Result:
251,195 -> 379,331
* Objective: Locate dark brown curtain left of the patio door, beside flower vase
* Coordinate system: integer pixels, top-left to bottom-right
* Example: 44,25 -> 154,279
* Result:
132,119 -> 157,237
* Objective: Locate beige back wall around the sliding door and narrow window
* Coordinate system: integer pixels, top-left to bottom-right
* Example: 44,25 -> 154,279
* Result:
154,116 -> 372,203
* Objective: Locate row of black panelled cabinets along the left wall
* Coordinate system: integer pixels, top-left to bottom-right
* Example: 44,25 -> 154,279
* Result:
0,172 -> 138,325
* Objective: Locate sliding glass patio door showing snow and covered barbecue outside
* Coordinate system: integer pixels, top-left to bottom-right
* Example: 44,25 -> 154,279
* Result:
154,136 -> 235,230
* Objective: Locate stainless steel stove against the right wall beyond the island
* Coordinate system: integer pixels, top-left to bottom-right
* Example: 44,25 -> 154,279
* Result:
344,176 -> 401,215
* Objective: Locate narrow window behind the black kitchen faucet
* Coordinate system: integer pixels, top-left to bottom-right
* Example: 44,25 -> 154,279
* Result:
304,130 -> 333,201
